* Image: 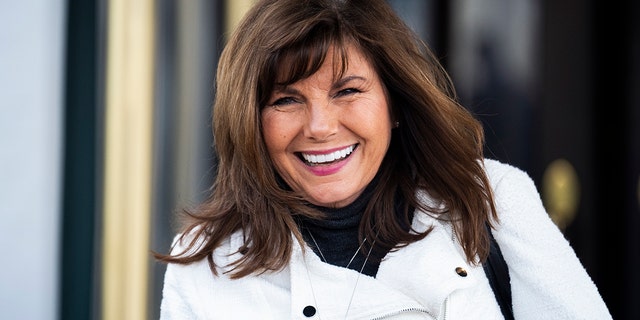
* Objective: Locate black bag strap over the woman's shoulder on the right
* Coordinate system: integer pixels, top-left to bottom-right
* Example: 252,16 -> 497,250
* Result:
482,224 -> 514,320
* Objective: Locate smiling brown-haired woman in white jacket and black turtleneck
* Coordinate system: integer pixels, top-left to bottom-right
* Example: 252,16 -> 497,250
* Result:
157,0 -> 611,319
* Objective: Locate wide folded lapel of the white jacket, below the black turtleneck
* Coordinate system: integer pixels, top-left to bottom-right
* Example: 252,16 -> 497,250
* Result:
289,206 -> 477,319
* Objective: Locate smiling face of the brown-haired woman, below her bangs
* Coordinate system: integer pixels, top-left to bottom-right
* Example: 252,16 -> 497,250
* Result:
261,47 -> 392,208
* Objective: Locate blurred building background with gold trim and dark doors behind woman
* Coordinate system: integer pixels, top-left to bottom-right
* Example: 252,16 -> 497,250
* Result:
0,0 -> 640,320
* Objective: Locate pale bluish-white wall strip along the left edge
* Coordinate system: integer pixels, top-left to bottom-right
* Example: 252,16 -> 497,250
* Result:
0,0 -> 65,320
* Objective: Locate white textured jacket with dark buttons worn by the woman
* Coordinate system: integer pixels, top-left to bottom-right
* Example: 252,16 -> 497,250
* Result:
160,160 -> 611,320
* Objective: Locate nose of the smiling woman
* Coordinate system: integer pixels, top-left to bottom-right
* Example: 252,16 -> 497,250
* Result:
304,101 -> 339,141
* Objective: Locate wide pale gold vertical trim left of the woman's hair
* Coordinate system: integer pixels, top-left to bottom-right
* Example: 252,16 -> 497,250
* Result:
101,0 -> 154,320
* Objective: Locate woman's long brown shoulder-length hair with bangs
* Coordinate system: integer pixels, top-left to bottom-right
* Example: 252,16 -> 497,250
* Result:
156,0 -> 497,278
